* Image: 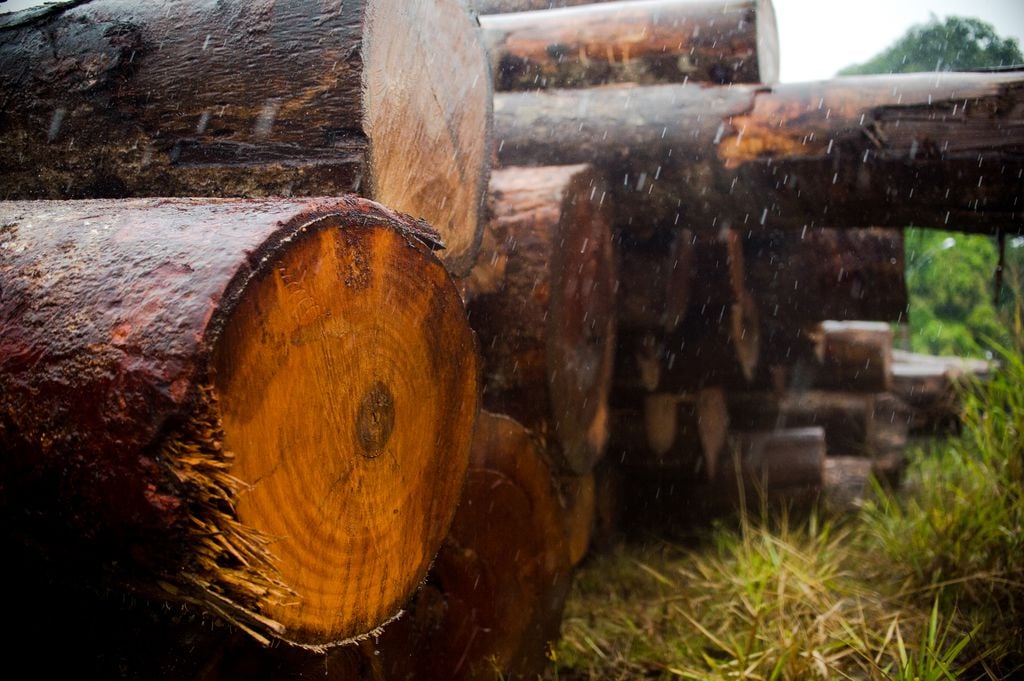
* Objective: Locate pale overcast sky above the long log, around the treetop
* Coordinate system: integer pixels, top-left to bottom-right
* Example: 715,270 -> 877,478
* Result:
6,0 -> 1024,82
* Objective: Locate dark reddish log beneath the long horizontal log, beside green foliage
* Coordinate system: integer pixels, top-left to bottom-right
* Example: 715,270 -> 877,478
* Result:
744,227 -> 907,326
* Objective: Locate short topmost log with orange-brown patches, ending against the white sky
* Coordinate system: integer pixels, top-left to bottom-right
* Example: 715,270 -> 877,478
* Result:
480,0 -> 778,91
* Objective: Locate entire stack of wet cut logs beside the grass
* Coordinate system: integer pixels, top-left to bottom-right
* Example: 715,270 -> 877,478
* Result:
0,0 -> 1024,681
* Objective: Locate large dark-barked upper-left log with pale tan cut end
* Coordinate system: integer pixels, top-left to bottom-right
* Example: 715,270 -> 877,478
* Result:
0,0 -> 492,272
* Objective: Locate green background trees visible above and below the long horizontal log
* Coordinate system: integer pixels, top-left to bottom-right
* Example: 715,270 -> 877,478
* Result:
839,15 -> 1024,355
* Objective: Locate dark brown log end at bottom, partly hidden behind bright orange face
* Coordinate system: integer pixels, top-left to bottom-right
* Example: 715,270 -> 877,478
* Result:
377,412 -> 571,681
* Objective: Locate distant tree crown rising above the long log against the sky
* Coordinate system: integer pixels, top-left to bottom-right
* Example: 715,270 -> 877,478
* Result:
839,15 -> 1024,76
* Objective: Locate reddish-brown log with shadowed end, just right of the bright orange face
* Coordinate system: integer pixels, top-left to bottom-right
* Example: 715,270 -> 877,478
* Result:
465,166 -> 615,474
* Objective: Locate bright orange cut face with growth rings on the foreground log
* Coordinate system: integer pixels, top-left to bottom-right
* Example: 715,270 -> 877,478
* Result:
213,225 -> 476,645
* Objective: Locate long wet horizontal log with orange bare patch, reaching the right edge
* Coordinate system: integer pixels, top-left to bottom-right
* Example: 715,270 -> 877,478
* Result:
495,72 -> 1024,232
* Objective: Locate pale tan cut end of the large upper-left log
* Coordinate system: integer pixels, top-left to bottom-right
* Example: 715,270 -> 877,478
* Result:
364,0 -> 492,274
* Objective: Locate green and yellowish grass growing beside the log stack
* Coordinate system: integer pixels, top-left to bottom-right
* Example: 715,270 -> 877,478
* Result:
548,337 -> 1024,681
